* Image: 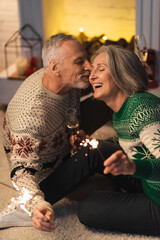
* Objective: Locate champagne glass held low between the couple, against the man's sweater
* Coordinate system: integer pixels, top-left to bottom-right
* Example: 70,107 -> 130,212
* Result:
66,108 -> 79,136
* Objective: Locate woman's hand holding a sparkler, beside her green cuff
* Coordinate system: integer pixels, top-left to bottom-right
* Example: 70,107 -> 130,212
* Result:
104,150 -> 136,176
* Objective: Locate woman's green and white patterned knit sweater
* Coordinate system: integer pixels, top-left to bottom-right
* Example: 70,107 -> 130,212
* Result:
113,93 -> 160,205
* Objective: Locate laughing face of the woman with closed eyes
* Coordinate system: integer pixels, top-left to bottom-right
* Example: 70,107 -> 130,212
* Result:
89,53 -> 120,103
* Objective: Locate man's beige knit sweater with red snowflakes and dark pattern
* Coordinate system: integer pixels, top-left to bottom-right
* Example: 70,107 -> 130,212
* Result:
3,69 -> 80,214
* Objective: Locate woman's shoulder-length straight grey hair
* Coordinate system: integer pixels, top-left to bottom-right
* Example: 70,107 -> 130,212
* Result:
91,45 -> 148,97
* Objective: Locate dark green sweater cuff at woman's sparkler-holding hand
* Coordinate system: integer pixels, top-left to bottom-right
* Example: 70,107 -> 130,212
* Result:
133,160 -> 152,179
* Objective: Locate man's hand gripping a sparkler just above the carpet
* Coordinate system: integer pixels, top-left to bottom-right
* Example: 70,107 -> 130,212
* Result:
32,207 -> 55,232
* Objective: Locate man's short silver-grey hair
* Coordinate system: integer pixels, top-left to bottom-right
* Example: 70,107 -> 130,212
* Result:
42,33 -> 78,68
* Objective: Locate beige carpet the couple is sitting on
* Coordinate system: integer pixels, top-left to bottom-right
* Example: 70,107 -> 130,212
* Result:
0,111 -> 160,240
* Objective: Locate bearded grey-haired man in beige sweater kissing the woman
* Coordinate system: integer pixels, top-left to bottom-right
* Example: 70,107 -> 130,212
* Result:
0,34 -> 120,232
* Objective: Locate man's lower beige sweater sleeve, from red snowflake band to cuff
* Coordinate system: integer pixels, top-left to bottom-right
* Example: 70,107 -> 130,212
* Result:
7,129 -> 52,215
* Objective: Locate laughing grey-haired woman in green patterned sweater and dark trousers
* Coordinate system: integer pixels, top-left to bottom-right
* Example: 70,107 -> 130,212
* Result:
78,45 -> 160,235
